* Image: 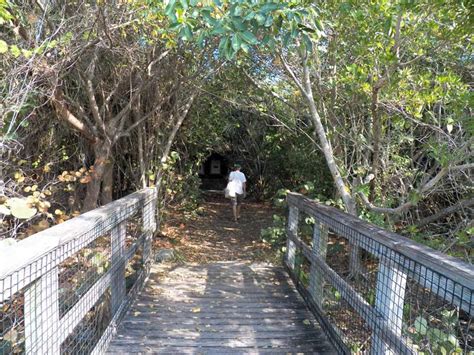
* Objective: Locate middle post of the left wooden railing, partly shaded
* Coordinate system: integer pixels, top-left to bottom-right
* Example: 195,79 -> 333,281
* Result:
110,222 -> 127,315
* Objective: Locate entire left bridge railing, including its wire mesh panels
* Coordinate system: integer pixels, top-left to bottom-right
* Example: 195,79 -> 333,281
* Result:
0,188 -> 156,354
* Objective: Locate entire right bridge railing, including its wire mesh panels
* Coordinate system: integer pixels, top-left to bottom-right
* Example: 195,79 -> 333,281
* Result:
286,193 -> 474,354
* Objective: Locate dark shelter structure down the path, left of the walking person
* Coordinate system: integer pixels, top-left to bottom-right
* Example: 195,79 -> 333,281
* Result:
199,153 -> 230,190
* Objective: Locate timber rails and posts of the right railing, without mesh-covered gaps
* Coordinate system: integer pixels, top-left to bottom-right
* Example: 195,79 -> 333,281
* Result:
286,193 -> 474,354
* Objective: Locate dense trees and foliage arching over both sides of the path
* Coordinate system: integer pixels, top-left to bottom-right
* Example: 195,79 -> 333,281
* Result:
0,0 -> 474,260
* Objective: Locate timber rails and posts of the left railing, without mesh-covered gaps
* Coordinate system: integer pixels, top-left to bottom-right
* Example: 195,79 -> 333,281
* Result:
0,188 -> 157,354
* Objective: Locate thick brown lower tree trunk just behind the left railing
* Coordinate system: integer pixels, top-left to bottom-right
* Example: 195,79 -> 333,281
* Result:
82,141 -> 111,212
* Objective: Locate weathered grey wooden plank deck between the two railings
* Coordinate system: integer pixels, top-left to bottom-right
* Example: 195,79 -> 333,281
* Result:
108,262 -> 335,354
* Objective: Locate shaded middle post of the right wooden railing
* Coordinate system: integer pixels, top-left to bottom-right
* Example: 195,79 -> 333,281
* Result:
309,221 -> 328,308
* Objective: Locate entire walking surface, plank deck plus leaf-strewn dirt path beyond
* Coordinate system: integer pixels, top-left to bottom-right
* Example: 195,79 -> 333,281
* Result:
109,198 -> 334,354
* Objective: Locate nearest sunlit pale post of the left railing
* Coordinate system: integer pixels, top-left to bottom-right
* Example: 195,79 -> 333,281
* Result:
25,267 -> 61,354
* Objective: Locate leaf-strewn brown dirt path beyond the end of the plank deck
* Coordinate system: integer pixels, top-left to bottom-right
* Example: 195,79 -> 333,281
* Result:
157,195 -> 274,263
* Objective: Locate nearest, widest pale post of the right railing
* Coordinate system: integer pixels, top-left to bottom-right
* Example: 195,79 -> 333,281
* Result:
371,258 -> 407,355
